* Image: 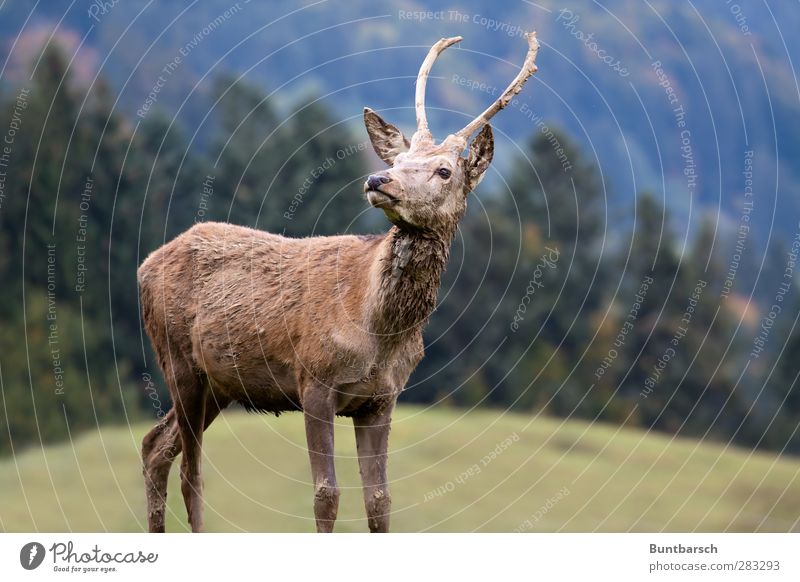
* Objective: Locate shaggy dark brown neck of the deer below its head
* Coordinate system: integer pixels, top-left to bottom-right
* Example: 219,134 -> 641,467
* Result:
368,226 -> 455,343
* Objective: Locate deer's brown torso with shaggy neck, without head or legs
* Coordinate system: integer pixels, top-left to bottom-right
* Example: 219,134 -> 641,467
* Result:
139,223 -> 449,416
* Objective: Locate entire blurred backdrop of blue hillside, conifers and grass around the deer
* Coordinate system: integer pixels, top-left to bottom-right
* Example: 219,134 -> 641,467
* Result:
0,0 -> 800,531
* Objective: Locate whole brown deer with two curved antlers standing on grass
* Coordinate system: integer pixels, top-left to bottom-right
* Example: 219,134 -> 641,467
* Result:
137,32 -> 539,533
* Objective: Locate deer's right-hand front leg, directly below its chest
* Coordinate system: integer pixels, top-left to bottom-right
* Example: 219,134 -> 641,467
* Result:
353,402 -> 394,533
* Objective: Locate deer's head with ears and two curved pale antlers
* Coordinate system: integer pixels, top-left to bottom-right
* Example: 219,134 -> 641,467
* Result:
364,33 -> 539,230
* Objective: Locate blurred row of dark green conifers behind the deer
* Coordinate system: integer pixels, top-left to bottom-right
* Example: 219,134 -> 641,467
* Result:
0,48 -> 800,453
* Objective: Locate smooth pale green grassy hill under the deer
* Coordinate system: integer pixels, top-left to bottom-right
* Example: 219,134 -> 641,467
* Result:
0,407 -> 800,531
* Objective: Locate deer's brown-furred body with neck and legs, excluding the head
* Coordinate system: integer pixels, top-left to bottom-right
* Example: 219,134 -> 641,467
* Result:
138,218 -> 460,531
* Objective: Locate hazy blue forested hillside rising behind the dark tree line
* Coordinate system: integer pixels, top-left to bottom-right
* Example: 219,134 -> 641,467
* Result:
0,0 -> 800,245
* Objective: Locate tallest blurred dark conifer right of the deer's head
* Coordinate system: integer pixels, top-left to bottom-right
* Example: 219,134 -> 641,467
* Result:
509,131 -> 608,417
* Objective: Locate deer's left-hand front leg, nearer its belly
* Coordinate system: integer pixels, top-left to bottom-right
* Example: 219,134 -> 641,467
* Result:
303,384 -> 339,533
